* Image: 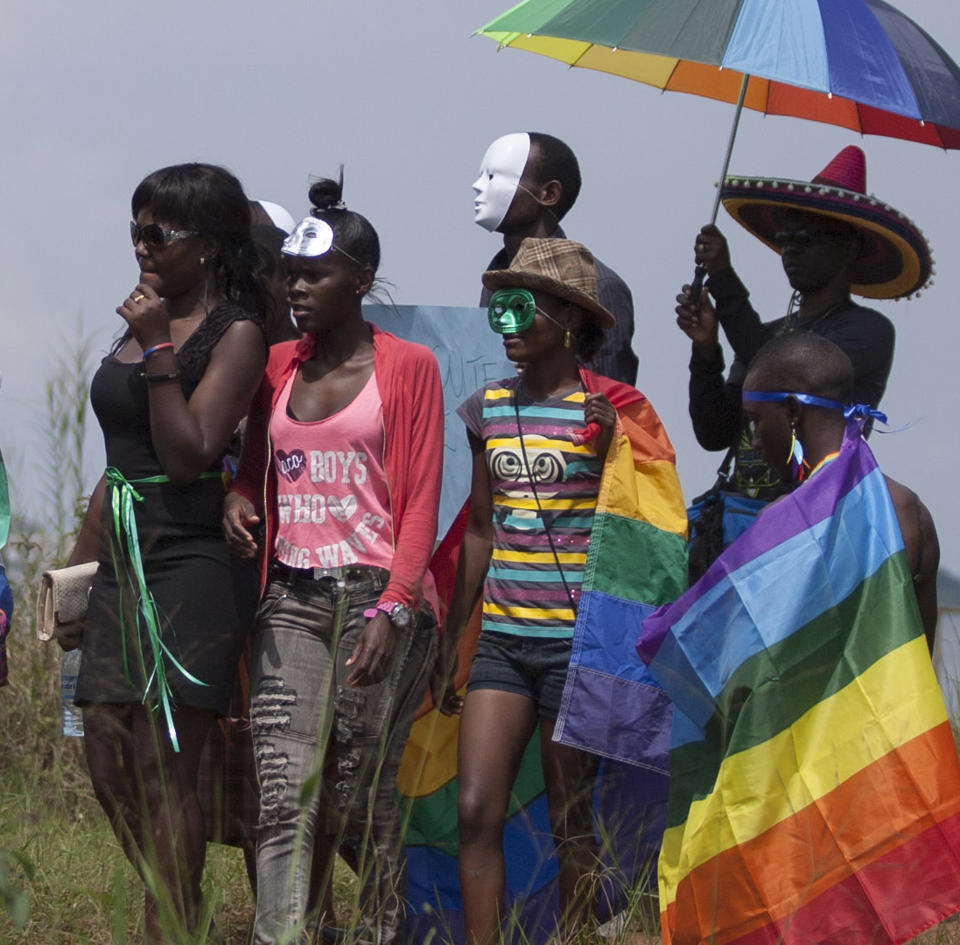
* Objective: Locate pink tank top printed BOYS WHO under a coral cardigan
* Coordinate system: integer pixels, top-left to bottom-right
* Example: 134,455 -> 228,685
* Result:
270,372 -> 393,571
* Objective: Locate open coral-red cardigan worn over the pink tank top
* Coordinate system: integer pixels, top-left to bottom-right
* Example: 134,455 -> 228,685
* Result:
230,324 -> 443,618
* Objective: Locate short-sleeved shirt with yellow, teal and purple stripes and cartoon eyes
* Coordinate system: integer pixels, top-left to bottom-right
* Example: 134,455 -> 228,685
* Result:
458,378 -> 603,639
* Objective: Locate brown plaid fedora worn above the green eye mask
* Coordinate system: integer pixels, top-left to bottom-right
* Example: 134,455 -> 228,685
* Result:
481,236 -> 616,328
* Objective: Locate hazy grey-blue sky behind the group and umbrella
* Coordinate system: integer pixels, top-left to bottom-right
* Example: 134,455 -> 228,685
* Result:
0,0 -> 960,571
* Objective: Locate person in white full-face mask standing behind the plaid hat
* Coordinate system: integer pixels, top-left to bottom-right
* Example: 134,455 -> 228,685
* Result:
473,131 -> 639,385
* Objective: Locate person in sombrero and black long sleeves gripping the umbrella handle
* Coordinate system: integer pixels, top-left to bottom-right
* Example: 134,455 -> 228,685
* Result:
676,146 -> 932,516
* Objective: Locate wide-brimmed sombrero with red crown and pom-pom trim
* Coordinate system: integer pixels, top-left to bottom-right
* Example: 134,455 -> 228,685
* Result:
720,145 -> 933,299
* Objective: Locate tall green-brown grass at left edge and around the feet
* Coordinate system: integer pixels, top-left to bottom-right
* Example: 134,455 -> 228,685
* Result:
0,325 -> 655,945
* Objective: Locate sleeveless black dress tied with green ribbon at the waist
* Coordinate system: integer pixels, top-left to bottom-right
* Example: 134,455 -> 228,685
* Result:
76,303 -> 258,714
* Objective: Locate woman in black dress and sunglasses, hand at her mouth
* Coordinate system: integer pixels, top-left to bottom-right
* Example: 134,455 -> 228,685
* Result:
65,164 -> 265,945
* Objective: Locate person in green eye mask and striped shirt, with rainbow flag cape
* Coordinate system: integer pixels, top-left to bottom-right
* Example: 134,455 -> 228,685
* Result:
414,238 -> 686,945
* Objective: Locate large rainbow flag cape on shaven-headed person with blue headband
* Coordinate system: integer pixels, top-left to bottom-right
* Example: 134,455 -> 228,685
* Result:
638,424 -> 960,945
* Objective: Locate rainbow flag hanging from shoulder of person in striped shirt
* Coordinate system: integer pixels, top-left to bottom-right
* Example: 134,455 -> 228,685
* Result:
554,376 -> 687,775
